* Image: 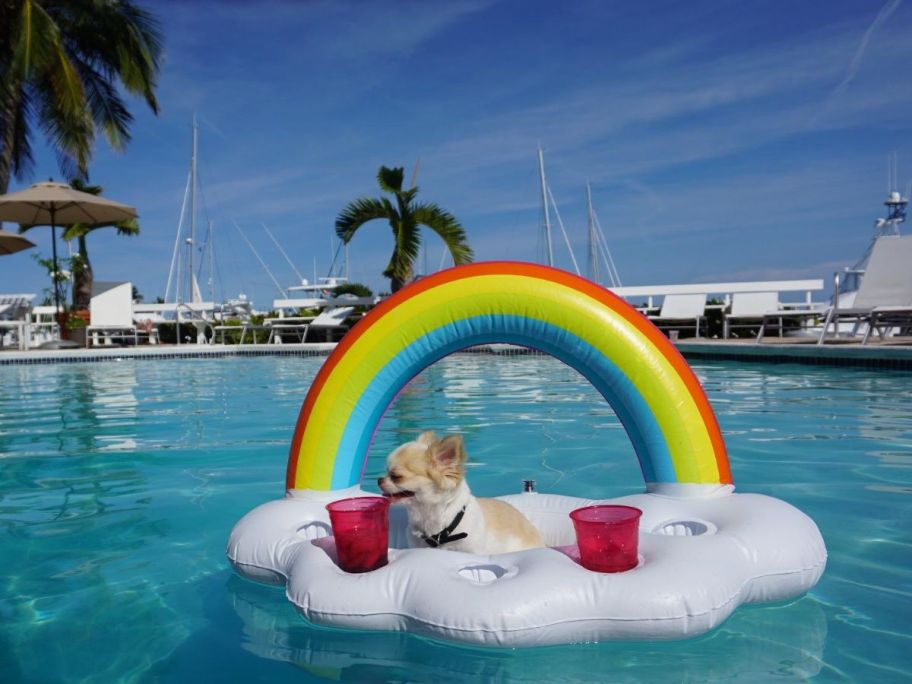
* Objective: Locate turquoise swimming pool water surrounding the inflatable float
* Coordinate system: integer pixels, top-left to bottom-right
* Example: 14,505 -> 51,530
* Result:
0,354 -> 912,684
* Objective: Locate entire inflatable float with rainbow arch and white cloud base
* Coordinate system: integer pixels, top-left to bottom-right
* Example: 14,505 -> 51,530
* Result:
227,262 -> 826,646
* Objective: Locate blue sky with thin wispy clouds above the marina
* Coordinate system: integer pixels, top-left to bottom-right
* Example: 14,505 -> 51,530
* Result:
0,0 -> 912,310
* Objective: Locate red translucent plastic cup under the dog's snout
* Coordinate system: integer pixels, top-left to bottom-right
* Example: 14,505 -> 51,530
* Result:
326,496 -> 389,572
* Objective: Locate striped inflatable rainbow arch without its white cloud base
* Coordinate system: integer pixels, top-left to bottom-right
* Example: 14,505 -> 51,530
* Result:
286,262 -> 732,491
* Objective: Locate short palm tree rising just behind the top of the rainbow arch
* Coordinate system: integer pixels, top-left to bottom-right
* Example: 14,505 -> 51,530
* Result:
336,166 -> 473,292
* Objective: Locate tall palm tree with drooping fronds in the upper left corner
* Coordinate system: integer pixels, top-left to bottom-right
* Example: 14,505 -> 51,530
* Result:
0,0 -> 162,194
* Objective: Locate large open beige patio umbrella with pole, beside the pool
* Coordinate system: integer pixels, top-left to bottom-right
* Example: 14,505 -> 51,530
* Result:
0,181 -> 136,313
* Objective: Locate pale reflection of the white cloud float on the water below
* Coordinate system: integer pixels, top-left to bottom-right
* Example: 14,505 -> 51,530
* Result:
228,577 -> 827,682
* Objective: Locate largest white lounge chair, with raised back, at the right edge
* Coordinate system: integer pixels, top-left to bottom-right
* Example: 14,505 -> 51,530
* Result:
817,235 -> 912,344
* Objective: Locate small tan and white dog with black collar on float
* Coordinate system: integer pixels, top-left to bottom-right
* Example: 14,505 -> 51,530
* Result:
377,432 -> 544,554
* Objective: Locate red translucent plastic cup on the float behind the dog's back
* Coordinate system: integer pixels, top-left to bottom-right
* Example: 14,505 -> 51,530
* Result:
570,504 -> 643,572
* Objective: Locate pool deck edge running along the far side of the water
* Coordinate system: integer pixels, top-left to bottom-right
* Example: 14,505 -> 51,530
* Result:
0,337 -> 912,370
